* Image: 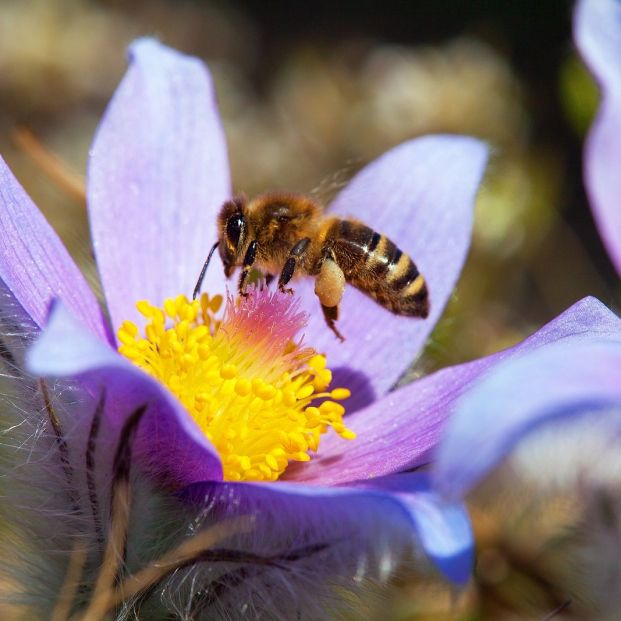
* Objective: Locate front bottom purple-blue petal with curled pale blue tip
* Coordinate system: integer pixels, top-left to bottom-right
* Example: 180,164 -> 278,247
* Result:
182,473 -> 473,585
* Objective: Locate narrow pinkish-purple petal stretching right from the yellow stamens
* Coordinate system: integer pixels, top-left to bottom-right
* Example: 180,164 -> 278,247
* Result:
287,298 -> 621,485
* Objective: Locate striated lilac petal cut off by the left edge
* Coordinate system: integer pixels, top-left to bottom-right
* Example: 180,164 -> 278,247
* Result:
0,158 -> 109,340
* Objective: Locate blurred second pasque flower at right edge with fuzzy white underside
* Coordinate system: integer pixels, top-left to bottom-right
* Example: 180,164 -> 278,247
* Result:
435,0 -> 621,548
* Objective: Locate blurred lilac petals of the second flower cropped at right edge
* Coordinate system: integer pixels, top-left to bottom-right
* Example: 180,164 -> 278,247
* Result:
436,0 -> 621,497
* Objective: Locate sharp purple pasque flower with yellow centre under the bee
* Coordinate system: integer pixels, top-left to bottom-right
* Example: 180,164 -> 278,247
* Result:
0,40 -> 487,619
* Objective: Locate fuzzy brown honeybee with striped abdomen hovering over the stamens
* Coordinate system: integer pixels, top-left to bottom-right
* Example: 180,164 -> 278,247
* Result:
194,192 -> 429,341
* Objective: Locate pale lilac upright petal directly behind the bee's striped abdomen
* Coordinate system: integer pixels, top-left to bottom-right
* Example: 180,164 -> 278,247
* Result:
301,135 -> 488,408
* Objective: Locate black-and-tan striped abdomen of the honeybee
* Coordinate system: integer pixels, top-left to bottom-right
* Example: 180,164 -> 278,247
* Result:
327,220 -> 429,317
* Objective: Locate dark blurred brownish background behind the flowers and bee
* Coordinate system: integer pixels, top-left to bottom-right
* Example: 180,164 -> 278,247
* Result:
0,0 -> 621,620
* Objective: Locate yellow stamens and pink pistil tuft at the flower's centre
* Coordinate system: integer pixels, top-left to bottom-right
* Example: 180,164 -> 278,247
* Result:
118,289 -> 356,481
